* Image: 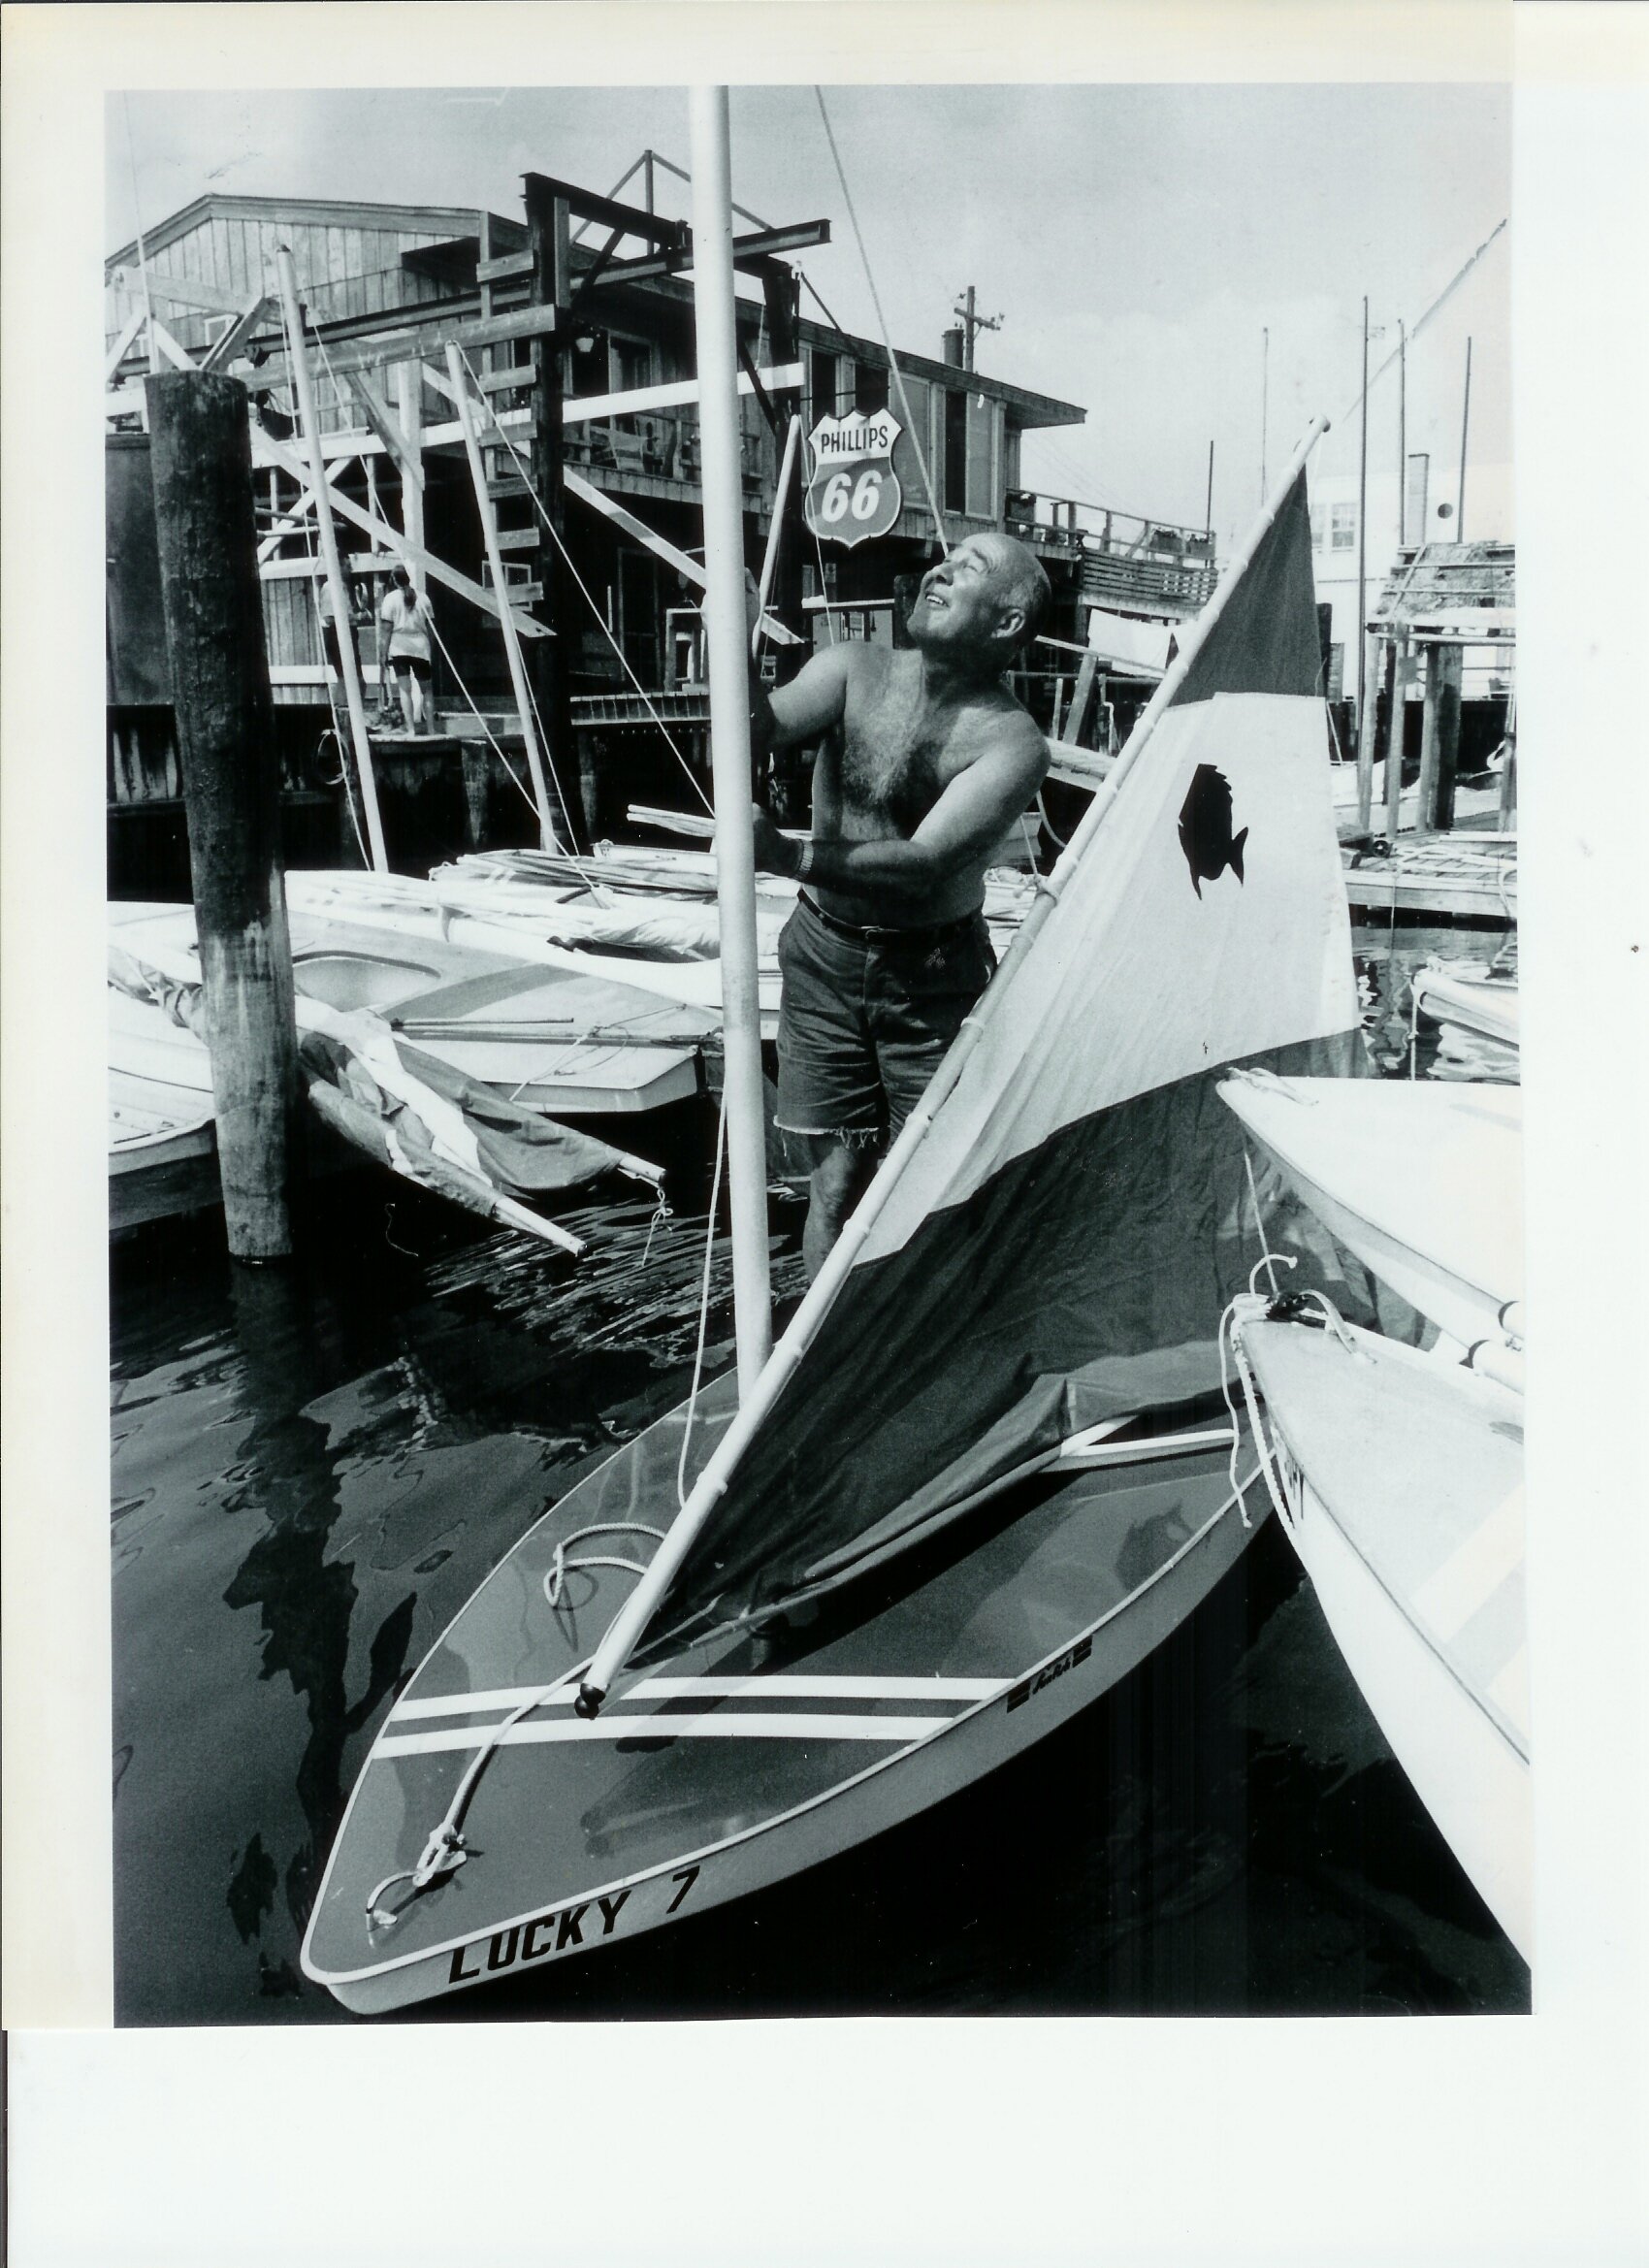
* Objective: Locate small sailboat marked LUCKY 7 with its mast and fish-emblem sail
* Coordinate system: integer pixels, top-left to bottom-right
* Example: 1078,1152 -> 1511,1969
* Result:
302,91 -> 1359,2012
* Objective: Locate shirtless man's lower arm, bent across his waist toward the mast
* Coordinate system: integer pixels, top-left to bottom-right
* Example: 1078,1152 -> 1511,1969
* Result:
756,717 -> 1048,905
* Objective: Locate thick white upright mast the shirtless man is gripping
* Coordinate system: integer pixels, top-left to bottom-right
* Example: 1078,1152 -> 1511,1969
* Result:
690,86 -> 771,1400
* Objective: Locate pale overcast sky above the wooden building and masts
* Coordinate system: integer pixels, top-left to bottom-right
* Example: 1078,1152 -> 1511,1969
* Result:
107,86 -> 1510,539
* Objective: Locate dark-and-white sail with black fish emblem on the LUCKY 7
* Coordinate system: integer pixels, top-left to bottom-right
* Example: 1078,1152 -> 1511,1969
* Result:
653,471 -> 1359,1660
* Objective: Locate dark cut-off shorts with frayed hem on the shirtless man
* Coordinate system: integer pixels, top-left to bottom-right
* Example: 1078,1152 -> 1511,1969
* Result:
776,896 -> 996,1150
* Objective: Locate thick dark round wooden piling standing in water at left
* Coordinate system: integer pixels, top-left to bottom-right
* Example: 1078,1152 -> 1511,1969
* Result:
146,370 -> 297,1261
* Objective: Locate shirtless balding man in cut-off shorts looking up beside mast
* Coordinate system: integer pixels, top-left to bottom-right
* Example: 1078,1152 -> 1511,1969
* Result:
753,533 -> 1048,1277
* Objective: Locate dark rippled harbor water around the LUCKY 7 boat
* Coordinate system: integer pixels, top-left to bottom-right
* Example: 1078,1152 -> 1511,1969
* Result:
112,930 -> 1529,2023
